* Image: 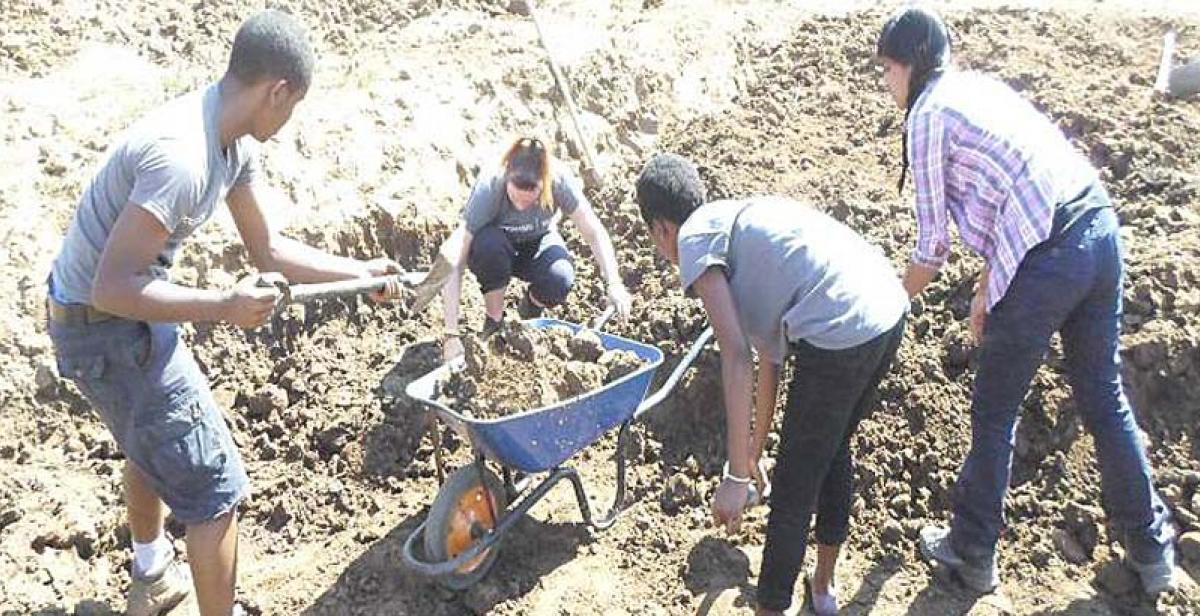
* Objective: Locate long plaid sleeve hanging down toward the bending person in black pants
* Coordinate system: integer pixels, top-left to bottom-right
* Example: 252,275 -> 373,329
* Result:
908,110 -> 950,269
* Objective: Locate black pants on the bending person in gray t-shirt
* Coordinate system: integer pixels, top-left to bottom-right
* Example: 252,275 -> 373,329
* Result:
758,317 -> 905,611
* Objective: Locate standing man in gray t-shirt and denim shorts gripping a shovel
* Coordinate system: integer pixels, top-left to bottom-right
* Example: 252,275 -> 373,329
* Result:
48,11 -> 398,615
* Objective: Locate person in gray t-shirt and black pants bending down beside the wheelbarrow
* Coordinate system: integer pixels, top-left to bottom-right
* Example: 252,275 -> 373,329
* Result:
637,155 -> 908,614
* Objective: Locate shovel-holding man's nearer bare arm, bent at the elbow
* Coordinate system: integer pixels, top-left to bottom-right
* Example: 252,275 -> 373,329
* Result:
91,203 -> 278,327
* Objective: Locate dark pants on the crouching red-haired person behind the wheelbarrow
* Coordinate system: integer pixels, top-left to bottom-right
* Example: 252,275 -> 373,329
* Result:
467,226 -> 575,306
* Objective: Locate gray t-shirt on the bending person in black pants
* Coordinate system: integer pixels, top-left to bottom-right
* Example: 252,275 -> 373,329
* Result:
679,197 -> 908,363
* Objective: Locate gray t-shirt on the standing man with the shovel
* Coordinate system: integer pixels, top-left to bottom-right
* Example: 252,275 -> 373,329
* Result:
52,84 -> 258,304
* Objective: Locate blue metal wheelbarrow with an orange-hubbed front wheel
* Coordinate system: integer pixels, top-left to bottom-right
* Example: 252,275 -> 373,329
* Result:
403,311 -> 713,590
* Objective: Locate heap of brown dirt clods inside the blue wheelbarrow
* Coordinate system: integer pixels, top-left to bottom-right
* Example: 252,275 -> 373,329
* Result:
443,319 -> 643,419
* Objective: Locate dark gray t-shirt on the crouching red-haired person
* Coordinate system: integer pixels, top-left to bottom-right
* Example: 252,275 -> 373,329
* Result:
462,168 -> 587,241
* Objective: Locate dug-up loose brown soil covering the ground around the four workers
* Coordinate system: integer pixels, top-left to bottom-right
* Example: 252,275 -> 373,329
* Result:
0,0 -> 1200,615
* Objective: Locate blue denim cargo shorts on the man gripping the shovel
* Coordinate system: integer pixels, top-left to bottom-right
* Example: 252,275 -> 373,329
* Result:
49,318 -> 250,524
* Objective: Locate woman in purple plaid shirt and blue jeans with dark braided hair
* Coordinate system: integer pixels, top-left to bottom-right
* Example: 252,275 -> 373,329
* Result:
877,8 -> 1175,594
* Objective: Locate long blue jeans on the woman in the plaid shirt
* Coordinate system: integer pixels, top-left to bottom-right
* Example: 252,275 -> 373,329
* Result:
950,192 -> 1174,563
